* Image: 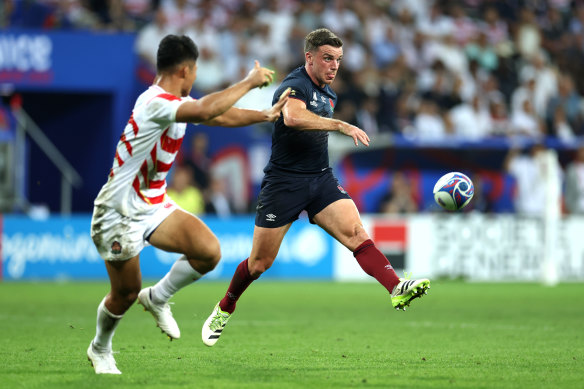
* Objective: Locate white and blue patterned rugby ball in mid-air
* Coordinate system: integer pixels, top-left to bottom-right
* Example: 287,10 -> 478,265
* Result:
434,172 -> 474,211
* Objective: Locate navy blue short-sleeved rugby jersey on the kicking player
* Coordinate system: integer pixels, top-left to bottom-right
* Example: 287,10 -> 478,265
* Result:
264,66 -> 337,174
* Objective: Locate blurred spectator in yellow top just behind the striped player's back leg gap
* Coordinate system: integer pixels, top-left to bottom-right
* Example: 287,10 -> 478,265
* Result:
166,162 -> 205,215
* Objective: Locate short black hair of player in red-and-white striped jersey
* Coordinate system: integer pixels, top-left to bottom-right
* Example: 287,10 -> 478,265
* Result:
156,34 -> 199,73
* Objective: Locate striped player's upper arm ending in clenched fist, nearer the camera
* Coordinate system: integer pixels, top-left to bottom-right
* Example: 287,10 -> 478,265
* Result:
176,61 -> 274,123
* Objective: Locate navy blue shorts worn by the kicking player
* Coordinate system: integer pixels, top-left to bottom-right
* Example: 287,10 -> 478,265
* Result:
255,169 -> 351,228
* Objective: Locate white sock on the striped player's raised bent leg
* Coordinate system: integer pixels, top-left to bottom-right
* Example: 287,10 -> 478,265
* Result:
152,255 -> 201,304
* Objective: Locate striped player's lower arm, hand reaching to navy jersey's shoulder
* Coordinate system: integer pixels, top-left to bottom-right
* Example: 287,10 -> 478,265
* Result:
204,88 -> 290,127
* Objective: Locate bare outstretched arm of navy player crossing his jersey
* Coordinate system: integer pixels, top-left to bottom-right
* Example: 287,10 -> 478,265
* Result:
282,99 -> 370,146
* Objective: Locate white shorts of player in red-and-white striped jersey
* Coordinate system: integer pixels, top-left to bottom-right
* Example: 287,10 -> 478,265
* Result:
91,197 -> 181,261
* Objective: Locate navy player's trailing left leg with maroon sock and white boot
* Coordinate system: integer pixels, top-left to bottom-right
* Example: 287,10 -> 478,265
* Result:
201,223 -> 292,346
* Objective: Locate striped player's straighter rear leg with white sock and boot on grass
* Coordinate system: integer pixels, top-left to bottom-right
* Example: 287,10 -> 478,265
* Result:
87,256 -> 142,374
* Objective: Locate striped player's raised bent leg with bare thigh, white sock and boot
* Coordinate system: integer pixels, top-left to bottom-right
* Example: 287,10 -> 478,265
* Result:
138,210 -> 221,340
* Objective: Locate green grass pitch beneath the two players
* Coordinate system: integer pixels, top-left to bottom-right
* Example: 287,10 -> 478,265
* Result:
0,281 -> 584,389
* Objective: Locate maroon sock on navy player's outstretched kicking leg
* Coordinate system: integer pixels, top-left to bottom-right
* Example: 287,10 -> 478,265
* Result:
353,239 -> 399,293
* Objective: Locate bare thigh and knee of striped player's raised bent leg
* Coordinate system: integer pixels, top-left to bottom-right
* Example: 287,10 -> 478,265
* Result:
148,209 -> 219,259
